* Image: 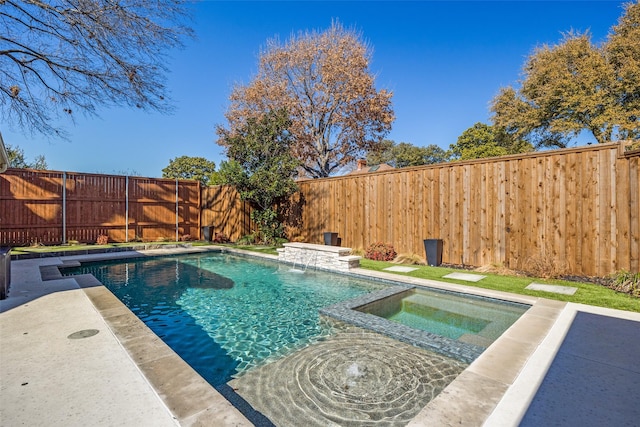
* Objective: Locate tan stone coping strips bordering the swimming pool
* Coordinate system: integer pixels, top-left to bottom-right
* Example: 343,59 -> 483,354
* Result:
3,247 -> 640,426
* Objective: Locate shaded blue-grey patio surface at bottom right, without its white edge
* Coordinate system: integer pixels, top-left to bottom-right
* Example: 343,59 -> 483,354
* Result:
520,312 -> 640,427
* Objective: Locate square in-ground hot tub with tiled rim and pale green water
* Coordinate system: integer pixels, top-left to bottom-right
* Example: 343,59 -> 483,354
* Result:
320,282 -> 531,363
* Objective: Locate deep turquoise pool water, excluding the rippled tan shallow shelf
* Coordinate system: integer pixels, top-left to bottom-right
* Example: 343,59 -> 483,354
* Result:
67,253 -> 386,386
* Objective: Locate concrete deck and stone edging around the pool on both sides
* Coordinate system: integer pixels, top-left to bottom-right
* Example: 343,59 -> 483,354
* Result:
0,249 -> 640,426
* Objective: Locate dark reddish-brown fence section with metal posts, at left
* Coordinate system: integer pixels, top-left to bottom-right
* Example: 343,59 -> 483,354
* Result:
0,169 -> 200,246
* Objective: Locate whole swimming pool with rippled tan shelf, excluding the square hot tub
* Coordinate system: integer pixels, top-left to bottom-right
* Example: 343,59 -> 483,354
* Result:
63,252 -> 536,427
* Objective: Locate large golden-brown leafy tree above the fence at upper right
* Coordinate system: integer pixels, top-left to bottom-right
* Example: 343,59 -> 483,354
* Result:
491,3 -> 640,147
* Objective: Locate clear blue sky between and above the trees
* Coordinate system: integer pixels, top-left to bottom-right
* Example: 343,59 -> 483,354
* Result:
0,0 -> 624,177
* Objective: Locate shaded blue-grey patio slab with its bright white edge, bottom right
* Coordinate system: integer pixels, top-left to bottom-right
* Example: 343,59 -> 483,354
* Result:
485,303 -> 640,427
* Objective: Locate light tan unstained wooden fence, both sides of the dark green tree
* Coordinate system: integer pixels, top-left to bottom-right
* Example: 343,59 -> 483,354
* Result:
203,143 -> 640,276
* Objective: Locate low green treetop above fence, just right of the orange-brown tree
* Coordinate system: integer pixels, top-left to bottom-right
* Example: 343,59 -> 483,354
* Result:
367,139 -> 449,168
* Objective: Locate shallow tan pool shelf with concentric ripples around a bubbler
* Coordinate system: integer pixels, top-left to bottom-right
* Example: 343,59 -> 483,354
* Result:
229,327 -> 467,426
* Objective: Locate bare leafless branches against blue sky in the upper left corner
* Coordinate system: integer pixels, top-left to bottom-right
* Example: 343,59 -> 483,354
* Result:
0,0 -> 191,137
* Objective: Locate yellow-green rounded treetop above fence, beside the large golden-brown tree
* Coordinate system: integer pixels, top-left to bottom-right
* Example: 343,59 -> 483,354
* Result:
449,122 -> 533,160
